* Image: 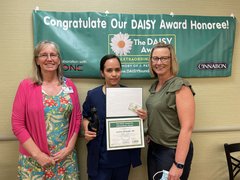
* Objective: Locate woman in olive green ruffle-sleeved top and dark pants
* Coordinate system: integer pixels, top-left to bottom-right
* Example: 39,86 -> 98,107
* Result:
146,43 -> 195,180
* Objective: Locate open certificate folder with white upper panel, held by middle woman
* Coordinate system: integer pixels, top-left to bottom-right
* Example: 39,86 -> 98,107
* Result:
106,87 -> 144,150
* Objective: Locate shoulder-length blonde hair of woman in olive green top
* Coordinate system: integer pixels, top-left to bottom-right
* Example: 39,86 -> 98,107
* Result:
149,42 -> 178,77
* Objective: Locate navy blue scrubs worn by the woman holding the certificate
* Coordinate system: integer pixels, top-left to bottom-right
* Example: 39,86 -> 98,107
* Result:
82,86 -> 141,180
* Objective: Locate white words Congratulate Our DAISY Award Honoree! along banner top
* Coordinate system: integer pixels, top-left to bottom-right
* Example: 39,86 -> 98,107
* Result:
43,16 -> 229,31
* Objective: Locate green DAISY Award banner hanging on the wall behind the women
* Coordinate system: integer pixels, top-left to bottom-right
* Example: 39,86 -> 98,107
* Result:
33,10 -> 236,78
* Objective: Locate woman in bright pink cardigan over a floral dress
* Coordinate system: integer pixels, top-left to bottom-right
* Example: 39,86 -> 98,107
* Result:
12,41 -> 81,179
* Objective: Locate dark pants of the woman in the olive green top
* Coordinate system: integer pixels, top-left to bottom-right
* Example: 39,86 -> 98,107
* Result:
147,141 -> 193,180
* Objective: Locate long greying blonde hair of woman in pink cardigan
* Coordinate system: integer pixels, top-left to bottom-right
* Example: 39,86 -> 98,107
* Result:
32,40 -> 63,85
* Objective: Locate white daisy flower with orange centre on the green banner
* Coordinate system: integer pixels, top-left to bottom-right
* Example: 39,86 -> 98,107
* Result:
110,32 -> 133,56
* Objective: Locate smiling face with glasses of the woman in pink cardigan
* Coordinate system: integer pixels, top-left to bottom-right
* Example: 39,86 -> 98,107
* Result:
36,44 -> 60,73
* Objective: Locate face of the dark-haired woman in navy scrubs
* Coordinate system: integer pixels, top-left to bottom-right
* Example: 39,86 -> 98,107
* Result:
101,58 -> 121,87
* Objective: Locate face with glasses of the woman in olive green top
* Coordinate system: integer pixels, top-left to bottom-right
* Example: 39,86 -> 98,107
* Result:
151,48 -> 172,76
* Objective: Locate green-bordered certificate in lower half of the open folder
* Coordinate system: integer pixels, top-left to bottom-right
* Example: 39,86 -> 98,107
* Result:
107,118 -> 144,150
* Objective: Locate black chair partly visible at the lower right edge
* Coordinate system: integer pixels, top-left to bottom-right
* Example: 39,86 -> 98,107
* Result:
224,143 -> 240,180
